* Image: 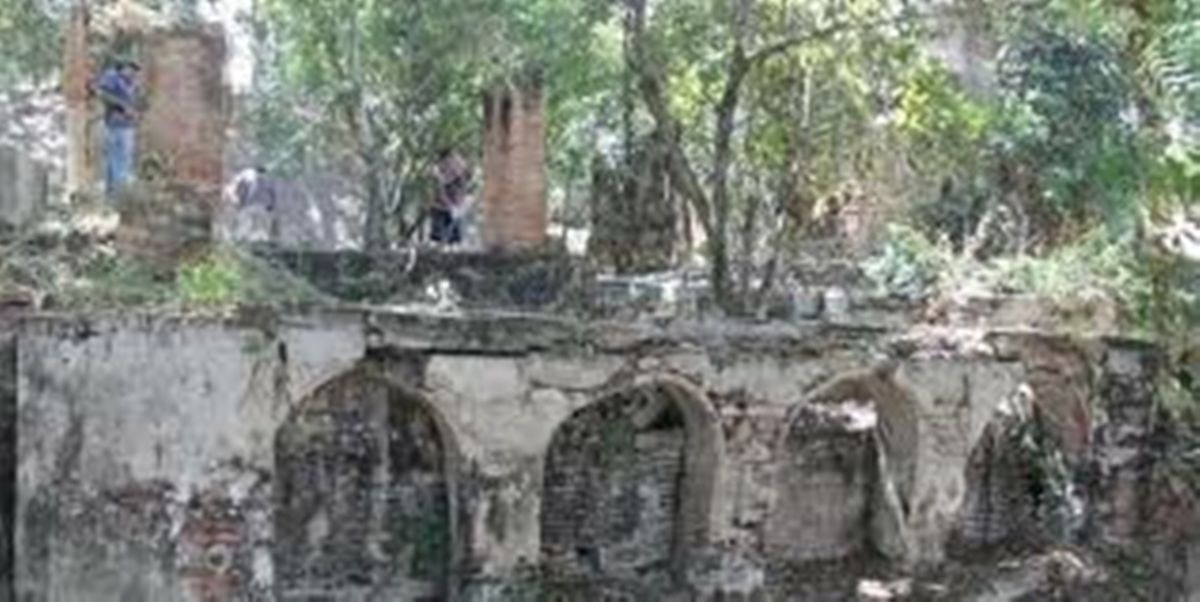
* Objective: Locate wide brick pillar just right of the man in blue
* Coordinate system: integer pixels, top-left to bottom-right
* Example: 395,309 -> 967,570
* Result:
138,26 -> 227,197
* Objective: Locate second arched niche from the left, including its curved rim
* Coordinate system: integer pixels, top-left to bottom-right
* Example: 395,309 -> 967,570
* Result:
541,378 -> 722,597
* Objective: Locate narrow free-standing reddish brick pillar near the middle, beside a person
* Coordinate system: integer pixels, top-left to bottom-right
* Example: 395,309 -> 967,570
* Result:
484,78 -> 547,249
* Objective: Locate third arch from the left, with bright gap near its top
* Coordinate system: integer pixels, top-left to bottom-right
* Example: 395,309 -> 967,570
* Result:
763,369 -> 918,564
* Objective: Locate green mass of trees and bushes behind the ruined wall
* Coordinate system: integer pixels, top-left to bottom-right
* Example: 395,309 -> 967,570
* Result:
0,0 -> 1200,344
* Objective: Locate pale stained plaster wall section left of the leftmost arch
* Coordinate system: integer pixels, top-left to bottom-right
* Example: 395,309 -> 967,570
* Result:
16,317 -> 361,602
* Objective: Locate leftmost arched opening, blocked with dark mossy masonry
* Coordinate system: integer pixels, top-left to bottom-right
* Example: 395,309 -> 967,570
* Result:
275,372 -> 454,601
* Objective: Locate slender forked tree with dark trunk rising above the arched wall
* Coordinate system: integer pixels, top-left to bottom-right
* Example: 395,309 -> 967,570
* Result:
624,0 -> 931,312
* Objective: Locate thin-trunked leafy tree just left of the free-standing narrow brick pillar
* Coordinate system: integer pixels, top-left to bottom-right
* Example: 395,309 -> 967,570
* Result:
265,0 -> 473,249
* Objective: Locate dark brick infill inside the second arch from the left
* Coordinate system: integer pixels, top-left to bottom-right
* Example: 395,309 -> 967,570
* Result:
541,391 -> 686,597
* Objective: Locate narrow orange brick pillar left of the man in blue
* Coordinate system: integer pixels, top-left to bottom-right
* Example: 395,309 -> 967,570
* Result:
62,2 -> 92,197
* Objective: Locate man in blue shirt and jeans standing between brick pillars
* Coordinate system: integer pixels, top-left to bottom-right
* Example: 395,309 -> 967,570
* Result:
96,60 -> 139,199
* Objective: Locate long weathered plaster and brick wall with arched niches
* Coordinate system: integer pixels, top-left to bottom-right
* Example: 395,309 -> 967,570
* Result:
0,312 -> 1195,601
